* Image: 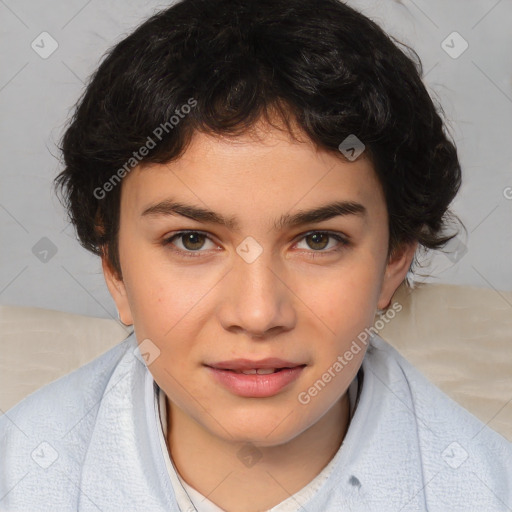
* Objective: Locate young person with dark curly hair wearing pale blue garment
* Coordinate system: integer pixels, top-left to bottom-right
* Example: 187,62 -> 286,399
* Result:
0,0 -> 512,512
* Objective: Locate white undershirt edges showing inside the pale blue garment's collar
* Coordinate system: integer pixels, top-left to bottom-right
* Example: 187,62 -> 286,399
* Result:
155,368 -> 363,512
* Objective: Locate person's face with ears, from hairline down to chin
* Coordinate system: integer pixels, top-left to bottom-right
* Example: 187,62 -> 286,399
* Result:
103,118 -> 415,446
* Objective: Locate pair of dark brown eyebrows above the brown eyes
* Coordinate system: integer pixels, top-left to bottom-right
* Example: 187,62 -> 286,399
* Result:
140,199 -> 368,232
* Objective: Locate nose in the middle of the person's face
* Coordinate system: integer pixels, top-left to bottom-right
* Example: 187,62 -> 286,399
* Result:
219,251 -> 297,340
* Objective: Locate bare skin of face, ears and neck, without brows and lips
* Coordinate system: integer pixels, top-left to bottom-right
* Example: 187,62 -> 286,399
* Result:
102,117 -> 417,512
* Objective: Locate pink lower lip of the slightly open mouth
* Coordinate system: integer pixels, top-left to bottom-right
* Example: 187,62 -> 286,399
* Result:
206,366 -> 304,398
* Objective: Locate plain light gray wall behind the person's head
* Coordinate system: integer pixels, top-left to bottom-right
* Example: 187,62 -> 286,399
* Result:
0,0 -> 512,318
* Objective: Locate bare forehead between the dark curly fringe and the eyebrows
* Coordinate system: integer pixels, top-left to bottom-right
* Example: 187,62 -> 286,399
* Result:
122,124 -> 384,224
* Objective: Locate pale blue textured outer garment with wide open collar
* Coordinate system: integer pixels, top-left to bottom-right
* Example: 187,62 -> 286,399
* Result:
0,334 -> 512,512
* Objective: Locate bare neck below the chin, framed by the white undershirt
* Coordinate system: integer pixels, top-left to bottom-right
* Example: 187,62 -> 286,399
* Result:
166,393 -> 350,512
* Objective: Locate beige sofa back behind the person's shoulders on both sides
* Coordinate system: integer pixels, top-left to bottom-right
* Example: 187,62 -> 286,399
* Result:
0,284 -> 512,442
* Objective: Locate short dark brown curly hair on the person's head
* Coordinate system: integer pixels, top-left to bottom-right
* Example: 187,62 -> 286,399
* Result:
54,0 -> 461,288
